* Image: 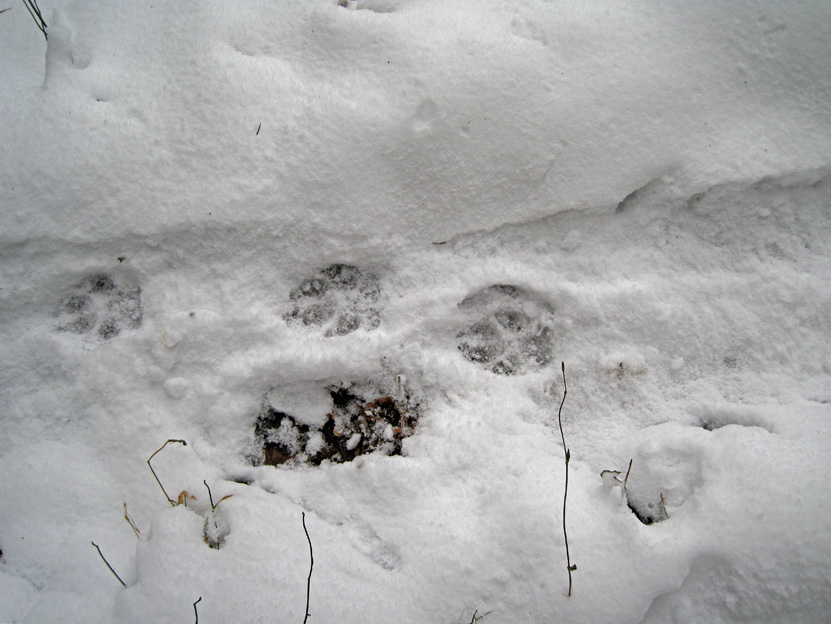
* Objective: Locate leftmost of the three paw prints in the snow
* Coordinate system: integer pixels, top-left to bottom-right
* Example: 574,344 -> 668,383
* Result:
56,273 -> 144,340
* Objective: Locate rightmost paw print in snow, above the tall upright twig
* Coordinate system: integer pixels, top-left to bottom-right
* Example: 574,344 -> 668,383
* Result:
457,284 -> 553,375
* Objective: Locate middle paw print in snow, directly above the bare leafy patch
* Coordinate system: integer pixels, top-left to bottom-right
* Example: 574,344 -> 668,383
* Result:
284,264 -> 381,337
